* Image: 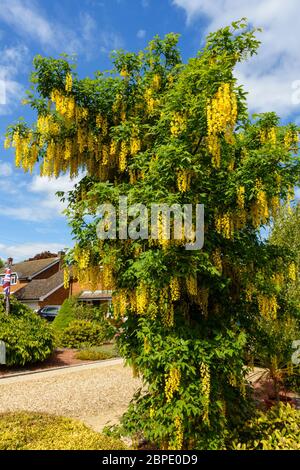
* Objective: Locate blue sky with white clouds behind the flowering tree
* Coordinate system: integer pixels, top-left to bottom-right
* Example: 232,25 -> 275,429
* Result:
0,0 -> 300,260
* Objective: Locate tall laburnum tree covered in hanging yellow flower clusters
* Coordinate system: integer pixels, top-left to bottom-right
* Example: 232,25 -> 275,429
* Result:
6,20 -> 299,449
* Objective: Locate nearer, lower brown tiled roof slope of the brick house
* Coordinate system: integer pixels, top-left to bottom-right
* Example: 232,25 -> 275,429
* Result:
14,271 -> 64,301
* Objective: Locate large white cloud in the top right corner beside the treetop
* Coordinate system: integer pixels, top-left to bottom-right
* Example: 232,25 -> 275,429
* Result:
173,0 -> 300,117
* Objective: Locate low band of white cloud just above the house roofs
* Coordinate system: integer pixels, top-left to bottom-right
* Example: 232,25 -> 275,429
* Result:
0,242 -> 66,262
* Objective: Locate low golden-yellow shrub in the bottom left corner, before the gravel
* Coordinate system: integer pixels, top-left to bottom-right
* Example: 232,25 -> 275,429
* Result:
0,412 -> 126,450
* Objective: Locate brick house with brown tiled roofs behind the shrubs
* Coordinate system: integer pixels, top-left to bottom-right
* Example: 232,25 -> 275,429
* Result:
0,252 -> 112,310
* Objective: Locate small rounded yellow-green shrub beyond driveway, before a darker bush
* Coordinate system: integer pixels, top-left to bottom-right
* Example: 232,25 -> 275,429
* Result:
60,320 -> 113,348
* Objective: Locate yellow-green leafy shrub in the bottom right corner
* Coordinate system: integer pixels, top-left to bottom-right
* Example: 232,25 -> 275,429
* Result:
228,403 -> 300,450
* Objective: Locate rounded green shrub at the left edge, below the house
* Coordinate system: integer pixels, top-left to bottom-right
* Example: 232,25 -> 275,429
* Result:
0,298 -> 54,366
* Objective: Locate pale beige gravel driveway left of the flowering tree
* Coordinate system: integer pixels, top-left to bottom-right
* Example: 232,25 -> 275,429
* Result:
0,359 -> 140,431
